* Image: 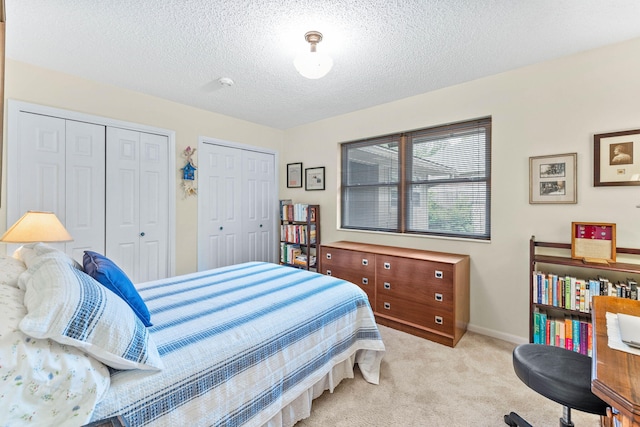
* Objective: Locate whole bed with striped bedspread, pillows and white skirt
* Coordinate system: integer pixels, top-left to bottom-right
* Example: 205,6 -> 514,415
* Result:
0,244 -> 384,426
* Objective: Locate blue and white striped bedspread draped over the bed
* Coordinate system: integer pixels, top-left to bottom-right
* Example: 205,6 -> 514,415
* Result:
93,262 -> 384,427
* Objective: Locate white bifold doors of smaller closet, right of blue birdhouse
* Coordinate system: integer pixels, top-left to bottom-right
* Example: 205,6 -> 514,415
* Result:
198,142 -> 278,270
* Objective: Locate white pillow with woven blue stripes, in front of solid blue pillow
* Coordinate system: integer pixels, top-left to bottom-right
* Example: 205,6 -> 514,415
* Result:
20,252 -> 163,370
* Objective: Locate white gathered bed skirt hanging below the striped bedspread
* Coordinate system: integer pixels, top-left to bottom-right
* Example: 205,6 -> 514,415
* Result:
263,350 -> 382,427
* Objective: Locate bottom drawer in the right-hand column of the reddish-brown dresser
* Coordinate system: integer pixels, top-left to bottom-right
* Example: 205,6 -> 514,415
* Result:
375,294 -> 454,335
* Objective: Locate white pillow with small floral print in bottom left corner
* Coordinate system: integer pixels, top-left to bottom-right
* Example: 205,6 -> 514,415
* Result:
0,284 -> 110,427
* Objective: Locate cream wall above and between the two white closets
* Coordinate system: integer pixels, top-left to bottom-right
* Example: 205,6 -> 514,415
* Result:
0,60 -> 283,274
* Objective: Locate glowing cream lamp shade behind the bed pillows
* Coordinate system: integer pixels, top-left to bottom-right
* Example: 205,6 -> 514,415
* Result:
0,211 -> 73,243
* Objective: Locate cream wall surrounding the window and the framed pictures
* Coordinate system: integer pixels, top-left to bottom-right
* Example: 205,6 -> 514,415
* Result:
280,39 -> 640,341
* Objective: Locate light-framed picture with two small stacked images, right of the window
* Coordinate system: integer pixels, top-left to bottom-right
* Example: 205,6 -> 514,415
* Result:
529,153 -> 578,204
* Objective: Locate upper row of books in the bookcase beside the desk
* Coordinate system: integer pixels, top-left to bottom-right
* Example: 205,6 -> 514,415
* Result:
532,271 -> 638,313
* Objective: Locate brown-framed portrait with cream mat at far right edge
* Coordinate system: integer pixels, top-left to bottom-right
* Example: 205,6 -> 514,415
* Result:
593,129 -> 640,187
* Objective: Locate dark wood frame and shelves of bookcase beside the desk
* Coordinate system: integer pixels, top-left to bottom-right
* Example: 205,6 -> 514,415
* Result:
529,236 -> 640,348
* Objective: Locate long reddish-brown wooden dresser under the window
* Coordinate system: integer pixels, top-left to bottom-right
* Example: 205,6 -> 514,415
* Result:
320,241 -> 469,347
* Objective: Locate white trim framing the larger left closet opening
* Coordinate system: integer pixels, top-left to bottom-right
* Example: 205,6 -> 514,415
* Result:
5,99 -> 176,277
